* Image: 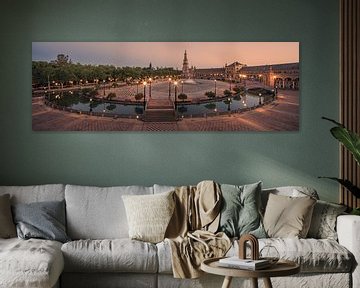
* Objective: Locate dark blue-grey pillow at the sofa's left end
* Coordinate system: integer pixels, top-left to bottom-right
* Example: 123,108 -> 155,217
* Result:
13,201 -> 70,243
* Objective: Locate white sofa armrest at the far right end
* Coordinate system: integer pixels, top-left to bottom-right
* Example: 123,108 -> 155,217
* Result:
336,215 -> 360,287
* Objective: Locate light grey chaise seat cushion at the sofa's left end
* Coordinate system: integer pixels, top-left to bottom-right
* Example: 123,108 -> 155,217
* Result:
0,238 -> 64,288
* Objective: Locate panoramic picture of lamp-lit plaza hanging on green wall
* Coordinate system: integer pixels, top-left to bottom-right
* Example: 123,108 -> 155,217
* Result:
32,42 -> 300,131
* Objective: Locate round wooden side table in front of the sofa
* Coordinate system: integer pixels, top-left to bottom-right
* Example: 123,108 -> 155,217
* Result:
201,258 -> 300,288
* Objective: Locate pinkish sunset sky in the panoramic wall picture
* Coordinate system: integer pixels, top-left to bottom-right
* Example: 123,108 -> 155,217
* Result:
32,42 -> 299,69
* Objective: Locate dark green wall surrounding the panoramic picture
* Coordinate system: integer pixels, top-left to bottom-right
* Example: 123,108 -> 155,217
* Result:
0,0 -> 339,201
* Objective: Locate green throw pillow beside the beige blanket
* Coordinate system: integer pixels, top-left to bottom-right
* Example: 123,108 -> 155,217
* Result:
219,182 -> 266,238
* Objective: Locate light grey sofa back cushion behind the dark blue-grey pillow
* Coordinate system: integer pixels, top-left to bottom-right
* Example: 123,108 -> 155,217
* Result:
0,184 -> 65,204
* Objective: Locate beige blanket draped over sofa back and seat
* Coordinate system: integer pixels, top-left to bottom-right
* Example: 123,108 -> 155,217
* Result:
165,181 -> 231,278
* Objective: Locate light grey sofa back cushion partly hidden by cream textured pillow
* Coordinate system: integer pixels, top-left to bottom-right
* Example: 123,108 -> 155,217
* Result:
65,185 -> 153,240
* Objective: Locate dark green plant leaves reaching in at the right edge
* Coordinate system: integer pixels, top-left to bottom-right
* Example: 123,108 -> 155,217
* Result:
319,117 -> 360,215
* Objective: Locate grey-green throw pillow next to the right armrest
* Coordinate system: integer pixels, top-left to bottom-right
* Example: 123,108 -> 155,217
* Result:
308,200 -> 346,240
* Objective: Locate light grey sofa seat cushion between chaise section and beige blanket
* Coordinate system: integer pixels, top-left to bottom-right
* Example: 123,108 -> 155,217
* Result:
61,238 -> 158,273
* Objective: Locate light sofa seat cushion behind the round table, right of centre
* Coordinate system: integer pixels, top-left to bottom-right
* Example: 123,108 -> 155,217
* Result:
157,238 -> 354,274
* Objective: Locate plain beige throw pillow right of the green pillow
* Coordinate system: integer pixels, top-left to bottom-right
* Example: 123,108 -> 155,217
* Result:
264,194 -> 316,238
